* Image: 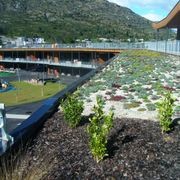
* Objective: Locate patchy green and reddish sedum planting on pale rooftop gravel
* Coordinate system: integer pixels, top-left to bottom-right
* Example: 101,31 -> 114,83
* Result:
80,50 -> 180,113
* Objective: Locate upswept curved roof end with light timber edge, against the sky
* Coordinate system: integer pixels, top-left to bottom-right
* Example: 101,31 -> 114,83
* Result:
152,0 -> 180,29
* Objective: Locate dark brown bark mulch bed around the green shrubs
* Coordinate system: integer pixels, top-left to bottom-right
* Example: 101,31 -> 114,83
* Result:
20,112 -> 180,180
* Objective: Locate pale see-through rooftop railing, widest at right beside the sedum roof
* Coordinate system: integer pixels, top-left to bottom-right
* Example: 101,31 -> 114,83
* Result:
2,40 -> 180,55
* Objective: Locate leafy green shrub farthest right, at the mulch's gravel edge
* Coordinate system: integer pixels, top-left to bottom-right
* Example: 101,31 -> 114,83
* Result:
157,91 -> 174,132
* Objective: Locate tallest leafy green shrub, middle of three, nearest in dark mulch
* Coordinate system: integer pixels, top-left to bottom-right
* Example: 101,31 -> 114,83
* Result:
87,96 -> 114,162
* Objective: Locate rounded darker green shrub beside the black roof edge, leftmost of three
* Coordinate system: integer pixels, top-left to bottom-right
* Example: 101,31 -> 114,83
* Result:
61,92 -> 84,128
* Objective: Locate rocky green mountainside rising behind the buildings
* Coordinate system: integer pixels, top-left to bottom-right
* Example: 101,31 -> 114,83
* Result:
0,0 -> 154,42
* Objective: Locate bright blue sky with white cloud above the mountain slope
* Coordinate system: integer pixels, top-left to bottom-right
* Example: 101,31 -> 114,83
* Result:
108,0 -> 179,21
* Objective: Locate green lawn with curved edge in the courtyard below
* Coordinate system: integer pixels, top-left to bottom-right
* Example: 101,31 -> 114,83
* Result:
0,82 -> 65,106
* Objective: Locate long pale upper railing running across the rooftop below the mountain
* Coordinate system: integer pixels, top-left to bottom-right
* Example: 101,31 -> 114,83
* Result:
0,40 -> 180,54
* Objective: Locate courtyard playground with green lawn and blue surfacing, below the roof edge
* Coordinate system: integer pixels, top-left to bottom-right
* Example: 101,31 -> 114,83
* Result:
0,69 -> 78,106
